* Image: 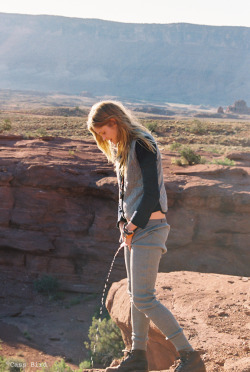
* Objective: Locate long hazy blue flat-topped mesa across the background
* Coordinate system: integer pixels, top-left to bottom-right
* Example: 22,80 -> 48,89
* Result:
0,13 -> 250,105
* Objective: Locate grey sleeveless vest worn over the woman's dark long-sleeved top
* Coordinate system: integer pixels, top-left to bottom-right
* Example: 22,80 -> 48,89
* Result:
117,134 -> 168,220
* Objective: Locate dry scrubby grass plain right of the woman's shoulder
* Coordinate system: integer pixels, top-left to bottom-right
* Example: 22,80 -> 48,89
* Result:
144,118 -> 250,155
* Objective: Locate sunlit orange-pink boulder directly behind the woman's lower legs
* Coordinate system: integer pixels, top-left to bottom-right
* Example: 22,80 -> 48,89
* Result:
106,271 -> 250,371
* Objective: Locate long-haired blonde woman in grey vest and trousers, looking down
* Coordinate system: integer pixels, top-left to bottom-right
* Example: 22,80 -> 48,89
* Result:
88,101 -> 205,372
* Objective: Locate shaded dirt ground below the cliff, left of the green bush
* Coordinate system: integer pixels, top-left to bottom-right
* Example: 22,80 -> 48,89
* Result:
0,271 -> 100,372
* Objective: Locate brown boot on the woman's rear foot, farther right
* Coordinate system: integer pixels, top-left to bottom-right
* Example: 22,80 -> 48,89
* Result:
174,351 -> 206,372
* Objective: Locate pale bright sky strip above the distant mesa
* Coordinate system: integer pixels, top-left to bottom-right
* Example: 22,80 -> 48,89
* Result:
0,0 -> 250,27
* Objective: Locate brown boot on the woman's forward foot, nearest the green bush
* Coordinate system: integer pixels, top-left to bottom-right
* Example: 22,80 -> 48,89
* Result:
105,350 -> 148,372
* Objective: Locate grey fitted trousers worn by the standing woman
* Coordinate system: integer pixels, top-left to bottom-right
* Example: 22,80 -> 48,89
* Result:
124,219 -> 185,350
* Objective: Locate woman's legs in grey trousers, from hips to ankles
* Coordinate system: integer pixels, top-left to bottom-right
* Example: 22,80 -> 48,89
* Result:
130,222 -> 193,351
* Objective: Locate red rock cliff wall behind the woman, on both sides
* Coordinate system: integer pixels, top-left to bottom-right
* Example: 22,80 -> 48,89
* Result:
0,136 -> 250,293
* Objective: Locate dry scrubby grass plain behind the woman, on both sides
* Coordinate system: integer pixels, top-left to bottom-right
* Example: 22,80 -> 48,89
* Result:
0,108 -> 250,156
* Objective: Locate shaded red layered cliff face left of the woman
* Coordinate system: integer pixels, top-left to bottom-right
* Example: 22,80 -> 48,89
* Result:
0,137 -> 123,292
